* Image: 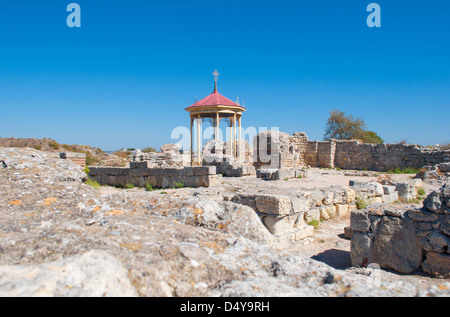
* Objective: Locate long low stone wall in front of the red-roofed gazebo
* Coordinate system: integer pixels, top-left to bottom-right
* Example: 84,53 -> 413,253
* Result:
89,161 -> 222,188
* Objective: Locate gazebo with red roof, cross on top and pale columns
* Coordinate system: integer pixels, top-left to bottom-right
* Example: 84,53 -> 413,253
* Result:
185,70 -> 246,165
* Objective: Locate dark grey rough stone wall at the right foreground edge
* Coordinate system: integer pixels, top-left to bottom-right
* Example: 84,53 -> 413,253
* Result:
351,184 -> 450,277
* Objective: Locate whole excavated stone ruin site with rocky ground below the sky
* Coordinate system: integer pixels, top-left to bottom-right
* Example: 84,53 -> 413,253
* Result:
0,131 -> 450,297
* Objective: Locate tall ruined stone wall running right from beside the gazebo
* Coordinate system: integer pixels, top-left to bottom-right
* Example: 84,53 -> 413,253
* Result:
254,131 -> 450,171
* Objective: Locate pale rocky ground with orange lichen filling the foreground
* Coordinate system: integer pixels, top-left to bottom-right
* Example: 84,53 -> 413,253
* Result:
0,148 -> 450,297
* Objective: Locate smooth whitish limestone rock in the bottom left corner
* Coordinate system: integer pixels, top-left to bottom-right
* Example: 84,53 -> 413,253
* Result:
0,250 -> 137,297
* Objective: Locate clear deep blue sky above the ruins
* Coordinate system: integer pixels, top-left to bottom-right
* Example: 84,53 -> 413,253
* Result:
0,0 -> 450,150
